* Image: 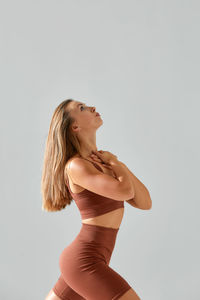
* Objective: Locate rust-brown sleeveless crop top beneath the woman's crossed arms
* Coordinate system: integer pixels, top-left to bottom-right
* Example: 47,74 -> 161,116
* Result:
66,158 -> 124,220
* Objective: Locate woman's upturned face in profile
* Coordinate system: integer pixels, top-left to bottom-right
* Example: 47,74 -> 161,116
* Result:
70,101 -> 103,129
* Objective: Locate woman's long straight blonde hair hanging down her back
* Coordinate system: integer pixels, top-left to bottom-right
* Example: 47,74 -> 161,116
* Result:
41,99 -> 80,212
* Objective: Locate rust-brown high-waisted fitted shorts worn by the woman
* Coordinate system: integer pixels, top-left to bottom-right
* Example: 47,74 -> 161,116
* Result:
53,223 -> 131,300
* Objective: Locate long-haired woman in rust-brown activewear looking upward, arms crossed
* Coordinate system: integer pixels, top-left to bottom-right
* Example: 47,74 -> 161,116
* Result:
41,99 -> 151,300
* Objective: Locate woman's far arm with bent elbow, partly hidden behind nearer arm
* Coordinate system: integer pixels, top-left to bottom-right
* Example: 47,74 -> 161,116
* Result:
117,161 -> 152,209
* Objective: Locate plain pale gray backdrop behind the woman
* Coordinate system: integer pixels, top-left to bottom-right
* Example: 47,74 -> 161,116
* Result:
0,0 -> 200,300
